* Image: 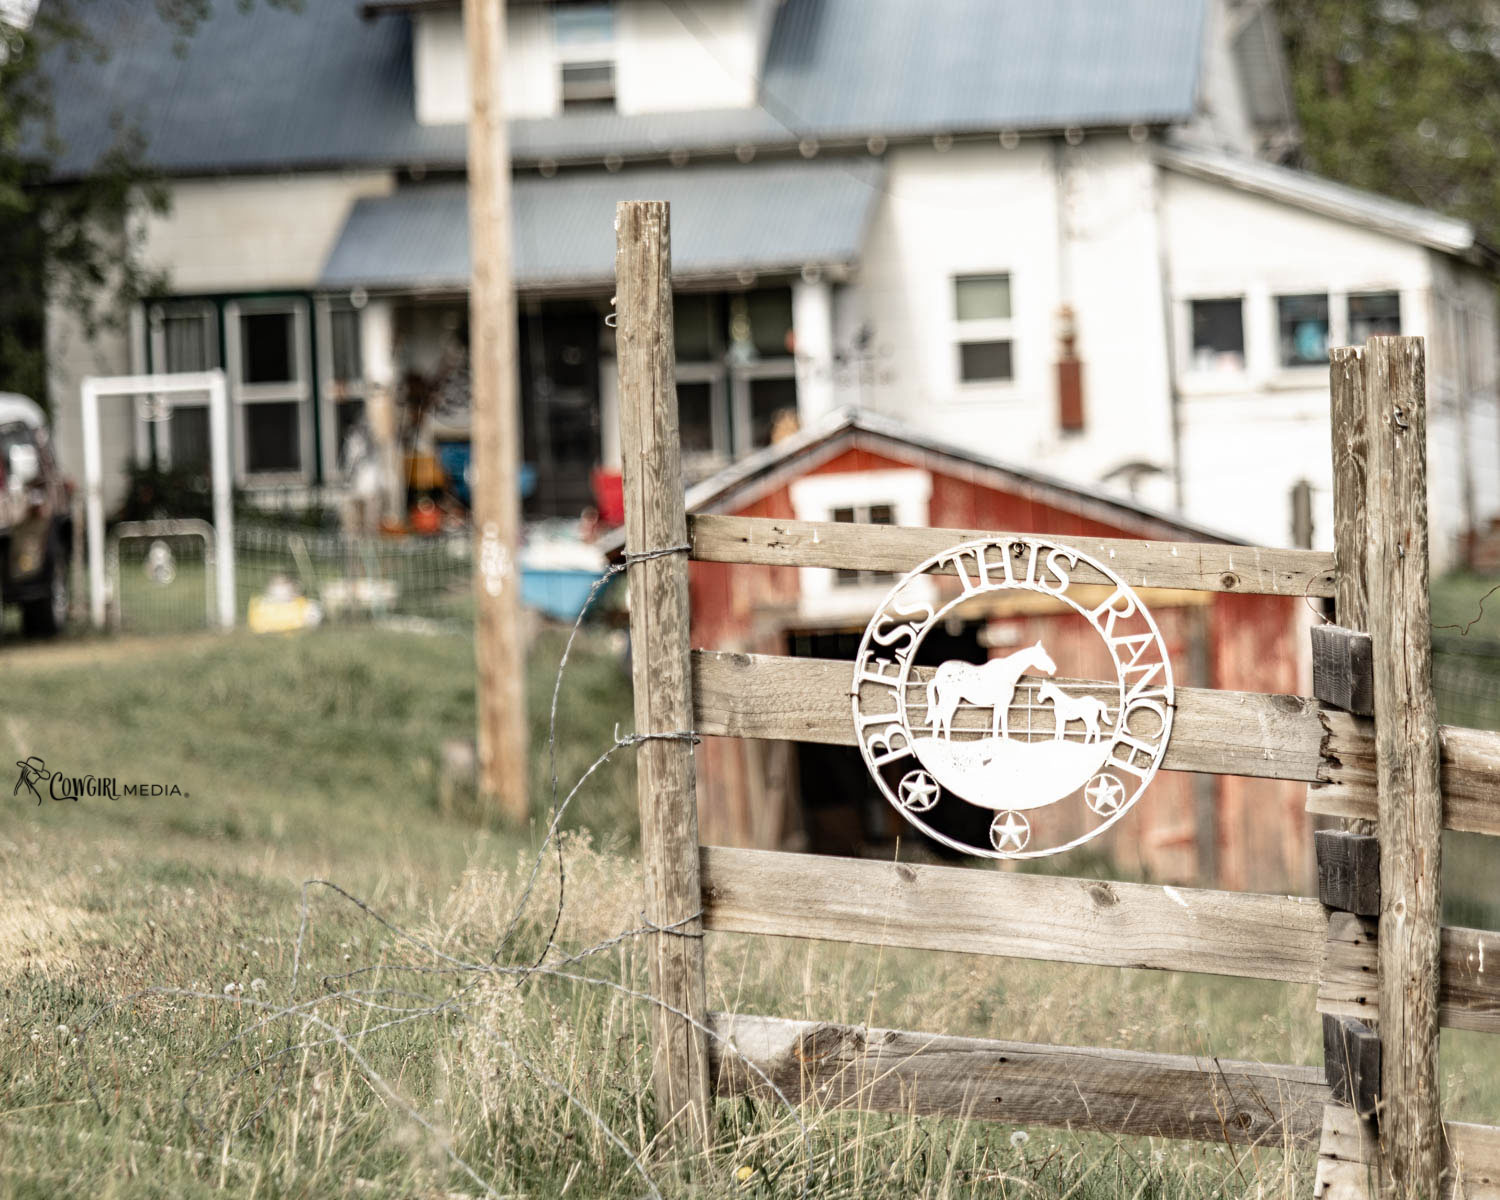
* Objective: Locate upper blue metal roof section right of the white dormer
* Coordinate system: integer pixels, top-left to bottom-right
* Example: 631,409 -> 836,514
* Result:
762,0 -> 1205,137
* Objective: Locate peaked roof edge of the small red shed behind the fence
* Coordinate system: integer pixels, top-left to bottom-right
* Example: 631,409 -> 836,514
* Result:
599,408 -> 1245,555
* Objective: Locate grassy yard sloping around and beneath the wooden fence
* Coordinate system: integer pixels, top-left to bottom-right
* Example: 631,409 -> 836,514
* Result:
0,588 -> 1500,1200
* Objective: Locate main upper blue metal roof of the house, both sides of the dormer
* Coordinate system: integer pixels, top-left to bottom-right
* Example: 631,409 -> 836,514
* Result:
32,0 -> 1208,177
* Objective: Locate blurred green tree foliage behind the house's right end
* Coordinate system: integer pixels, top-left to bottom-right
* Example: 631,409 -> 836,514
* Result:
1277,0 -> 1500,242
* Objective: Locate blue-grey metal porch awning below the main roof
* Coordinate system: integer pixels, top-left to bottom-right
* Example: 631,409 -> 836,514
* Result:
320,158 -> 884,291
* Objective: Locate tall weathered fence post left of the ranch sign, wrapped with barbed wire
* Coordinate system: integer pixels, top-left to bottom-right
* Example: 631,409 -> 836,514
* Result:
615,201 -> 710,1146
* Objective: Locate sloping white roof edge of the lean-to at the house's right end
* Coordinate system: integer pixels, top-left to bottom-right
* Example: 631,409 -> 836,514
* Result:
1154,146 -> 1500,267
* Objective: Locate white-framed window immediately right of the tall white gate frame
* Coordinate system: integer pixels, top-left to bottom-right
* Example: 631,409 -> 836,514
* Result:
225,300 -> 312,479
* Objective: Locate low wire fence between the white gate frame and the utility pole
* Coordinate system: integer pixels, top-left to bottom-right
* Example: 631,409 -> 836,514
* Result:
234,524 -> 474,630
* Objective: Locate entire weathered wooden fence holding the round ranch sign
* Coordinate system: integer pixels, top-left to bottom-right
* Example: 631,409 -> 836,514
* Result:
617,201 -> 1500,1200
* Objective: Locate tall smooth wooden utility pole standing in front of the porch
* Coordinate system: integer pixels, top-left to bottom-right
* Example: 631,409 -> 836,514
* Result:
464,0 -> 531,822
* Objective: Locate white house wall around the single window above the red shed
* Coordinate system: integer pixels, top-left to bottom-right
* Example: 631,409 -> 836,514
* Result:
839,138 -> 1172,503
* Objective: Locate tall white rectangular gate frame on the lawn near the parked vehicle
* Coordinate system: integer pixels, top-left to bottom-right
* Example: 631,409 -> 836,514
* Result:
83,371 -> 234,629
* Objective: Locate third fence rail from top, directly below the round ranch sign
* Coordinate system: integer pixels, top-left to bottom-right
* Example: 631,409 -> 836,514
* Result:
699,846 -> 1500,1034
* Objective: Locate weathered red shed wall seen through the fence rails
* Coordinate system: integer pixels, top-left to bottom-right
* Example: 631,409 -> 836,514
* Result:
690,447 -> 1311,890
